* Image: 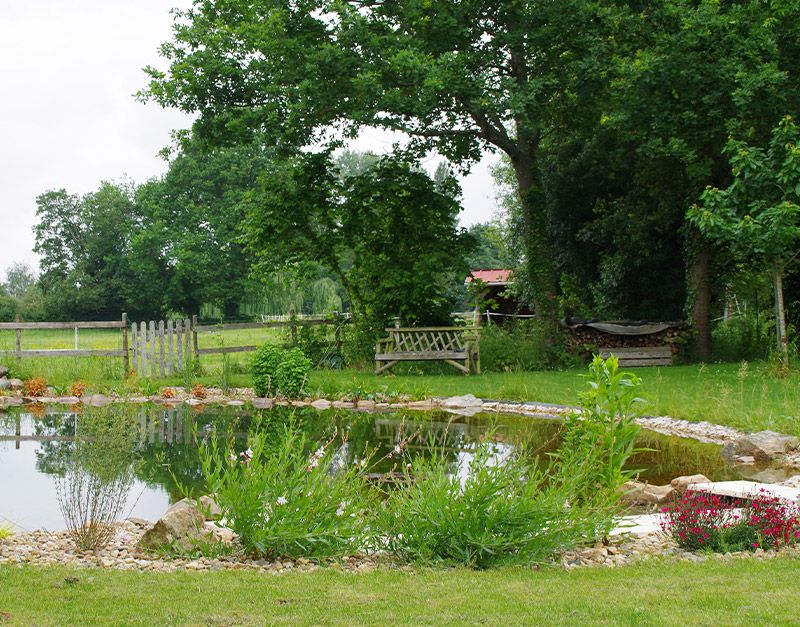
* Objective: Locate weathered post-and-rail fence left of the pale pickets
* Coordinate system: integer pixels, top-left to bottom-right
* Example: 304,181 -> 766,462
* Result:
0,314 -> 129,374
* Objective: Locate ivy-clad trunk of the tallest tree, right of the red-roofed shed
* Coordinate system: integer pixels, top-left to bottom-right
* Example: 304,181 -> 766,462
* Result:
511,151 -> 558,328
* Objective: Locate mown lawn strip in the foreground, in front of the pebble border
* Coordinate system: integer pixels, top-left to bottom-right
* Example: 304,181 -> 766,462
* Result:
0,558 -> 798,625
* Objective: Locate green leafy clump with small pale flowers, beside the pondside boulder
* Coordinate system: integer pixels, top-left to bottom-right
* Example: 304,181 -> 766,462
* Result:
200,423 -> 372,559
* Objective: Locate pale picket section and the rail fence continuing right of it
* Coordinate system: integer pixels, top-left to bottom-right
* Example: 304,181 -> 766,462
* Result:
131,315 -> 348,377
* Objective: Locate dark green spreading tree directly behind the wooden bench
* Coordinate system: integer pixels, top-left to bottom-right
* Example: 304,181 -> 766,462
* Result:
244,153 -> 470,354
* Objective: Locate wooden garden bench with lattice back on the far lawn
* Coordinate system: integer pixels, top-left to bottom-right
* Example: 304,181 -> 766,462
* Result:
375,327 -> 481,374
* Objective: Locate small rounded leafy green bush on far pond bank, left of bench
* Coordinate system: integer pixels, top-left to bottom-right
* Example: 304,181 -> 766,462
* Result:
251,344 -> 313,398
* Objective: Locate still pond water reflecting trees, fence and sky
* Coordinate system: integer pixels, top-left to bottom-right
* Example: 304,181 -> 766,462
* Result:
0,405 -> 768,530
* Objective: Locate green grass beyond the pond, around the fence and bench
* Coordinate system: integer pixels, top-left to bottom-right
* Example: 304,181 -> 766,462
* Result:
0,329 -> 800,435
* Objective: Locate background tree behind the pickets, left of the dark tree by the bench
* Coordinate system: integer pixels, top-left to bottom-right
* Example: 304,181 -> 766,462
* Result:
133,140 -> 271,319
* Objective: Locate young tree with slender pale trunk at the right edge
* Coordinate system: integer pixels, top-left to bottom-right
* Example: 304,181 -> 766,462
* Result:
687,116 -> 800,362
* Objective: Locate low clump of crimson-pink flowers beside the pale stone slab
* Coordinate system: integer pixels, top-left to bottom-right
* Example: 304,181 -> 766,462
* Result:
661,488 -> 800,553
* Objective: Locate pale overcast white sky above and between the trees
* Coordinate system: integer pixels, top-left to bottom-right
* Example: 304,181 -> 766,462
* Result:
0,0 -> 497,278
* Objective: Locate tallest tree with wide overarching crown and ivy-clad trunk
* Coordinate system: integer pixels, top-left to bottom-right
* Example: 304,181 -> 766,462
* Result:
142,0 -> 613,326
